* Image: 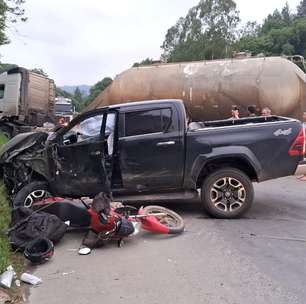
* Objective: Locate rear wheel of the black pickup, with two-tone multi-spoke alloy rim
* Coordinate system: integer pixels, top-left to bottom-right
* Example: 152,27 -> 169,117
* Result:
201,168 -> 254,219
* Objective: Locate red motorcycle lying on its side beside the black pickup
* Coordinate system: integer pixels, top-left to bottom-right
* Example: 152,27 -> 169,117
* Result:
34,197 -> 184,254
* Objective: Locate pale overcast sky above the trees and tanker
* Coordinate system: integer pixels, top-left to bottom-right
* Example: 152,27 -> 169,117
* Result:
0,0 -> 300,85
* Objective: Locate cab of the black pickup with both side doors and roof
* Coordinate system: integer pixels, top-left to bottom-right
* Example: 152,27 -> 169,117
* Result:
48,100 -> 186,196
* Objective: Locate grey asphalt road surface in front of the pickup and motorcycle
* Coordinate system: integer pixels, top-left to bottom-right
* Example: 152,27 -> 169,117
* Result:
28,177 -> 306,304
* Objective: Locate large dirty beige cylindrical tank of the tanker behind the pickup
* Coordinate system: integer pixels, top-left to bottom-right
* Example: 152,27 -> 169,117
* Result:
85,57 -> 306,121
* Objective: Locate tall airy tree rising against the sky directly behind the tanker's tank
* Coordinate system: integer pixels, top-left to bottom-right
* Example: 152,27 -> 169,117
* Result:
161,0 -> 239,62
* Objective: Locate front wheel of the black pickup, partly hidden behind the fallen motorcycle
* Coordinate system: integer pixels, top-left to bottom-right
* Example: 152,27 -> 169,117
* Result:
13,182 -> 51,208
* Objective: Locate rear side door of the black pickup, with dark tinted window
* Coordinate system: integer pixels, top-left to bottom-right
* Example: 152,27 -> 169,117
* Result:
119,106 -> 184,191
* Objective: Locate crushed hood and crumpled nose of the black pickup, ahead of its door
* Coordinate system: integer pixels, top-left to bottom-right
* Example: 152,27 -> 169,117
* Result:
0,132 -> 49,197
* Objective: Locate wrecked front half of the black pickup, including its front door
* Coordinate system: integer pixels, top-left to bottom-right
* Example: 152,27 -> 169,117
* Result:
0,105 -> 112,206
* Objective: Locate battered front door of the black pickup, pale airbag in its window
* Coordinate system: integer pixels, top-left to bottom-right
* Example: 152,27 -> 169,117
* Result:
51,112 -> 112,197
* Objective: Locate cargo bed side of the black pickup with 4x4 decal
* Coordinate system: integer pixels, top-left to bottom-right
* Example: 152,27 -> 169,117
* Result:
187,116 -> 301,186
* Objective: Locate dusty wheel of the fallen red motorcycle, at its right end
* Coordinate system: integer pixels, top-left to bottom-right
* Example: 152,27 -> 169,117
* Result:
143,206 -> 185,234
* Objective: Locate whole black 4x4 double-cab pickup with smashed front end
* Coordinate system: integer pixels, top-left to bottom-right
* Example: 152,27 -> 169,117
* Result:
0,100 -> 305,218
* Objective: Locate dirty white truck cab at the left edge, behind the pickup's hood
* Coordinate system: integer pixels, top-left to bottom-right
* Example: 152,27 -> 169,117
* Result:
0,67 -> 55,138
